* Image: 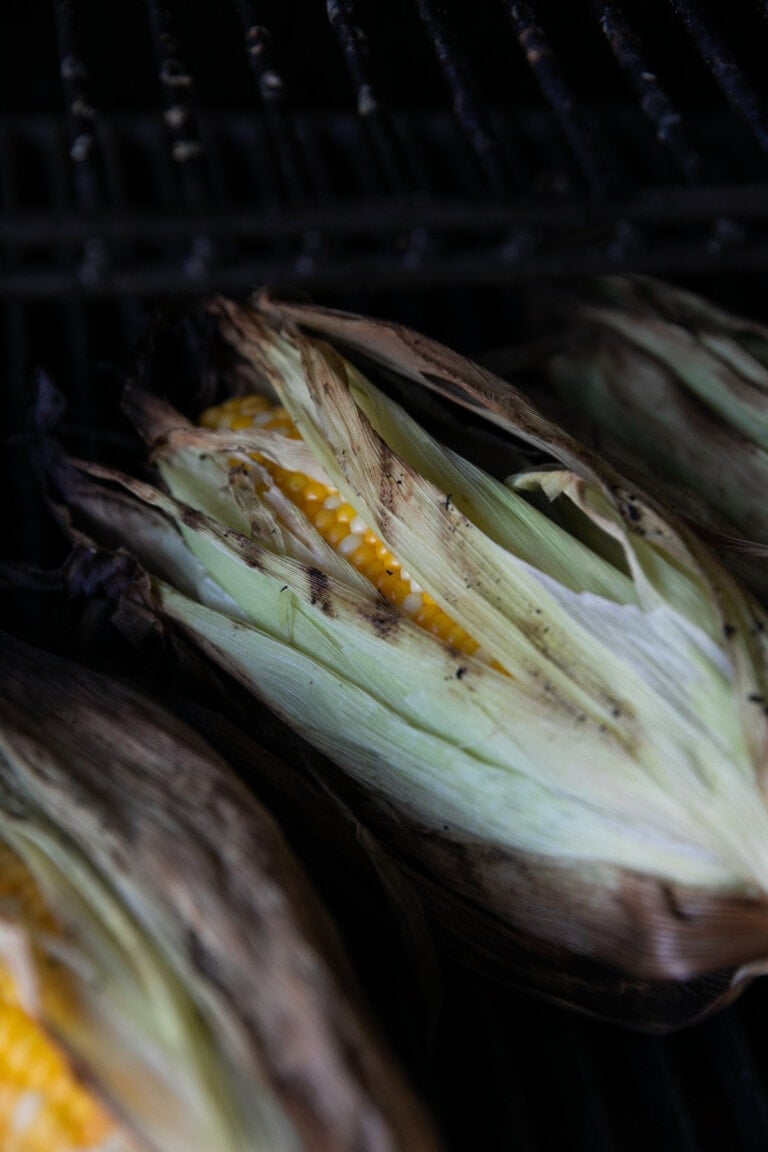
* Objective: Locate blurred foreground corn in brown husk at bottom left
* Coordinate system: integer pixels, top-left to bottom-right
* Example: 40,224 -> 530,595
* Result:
0,637 -> 436,1152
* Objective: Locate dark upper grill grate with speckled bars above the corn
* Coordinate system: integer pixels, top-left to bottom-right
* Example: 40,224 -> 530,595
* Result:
0,0 -> 768,297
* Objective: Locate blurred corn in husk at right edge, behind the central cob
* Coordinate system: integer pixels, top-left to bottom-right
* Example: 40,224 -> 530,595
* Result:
517,276 -> 768,596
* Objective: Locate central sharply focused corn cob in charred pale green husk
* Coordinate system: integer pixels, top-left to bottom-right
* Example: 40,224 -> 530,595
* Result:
58,302 -> 768,1018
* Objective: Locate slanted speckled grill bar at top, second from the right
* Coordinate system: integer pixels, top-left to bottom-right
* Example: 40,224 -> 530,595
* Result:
590,0 -> 702,181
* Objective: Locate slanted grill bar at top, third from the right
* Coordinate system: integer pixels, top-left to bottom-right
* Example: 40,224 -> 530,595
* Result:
504,0 -> 615,196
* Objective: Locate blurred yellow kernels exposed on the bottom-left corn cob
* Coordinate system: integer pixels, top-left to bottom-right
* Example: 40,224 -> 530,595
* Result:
0,844 -> 114,1152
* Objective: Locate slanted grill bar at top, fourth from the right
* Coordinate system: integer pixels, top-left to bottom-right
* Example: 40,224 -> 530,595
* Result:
416,0 -> 512,195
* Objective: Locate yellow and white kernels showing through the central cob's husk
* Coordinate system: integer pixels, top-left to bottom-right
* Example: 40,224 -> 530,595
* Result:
200,396 -> 479,654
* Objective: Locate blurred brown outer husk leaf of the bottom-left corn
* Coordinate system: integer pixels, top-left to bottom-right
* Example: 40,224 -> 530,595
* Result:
0,637 -> 438,1152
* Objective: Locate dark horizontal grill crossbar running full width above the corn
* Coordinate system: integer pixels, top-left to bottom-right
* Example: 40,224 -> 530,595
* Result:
0,161 -> 768,296
